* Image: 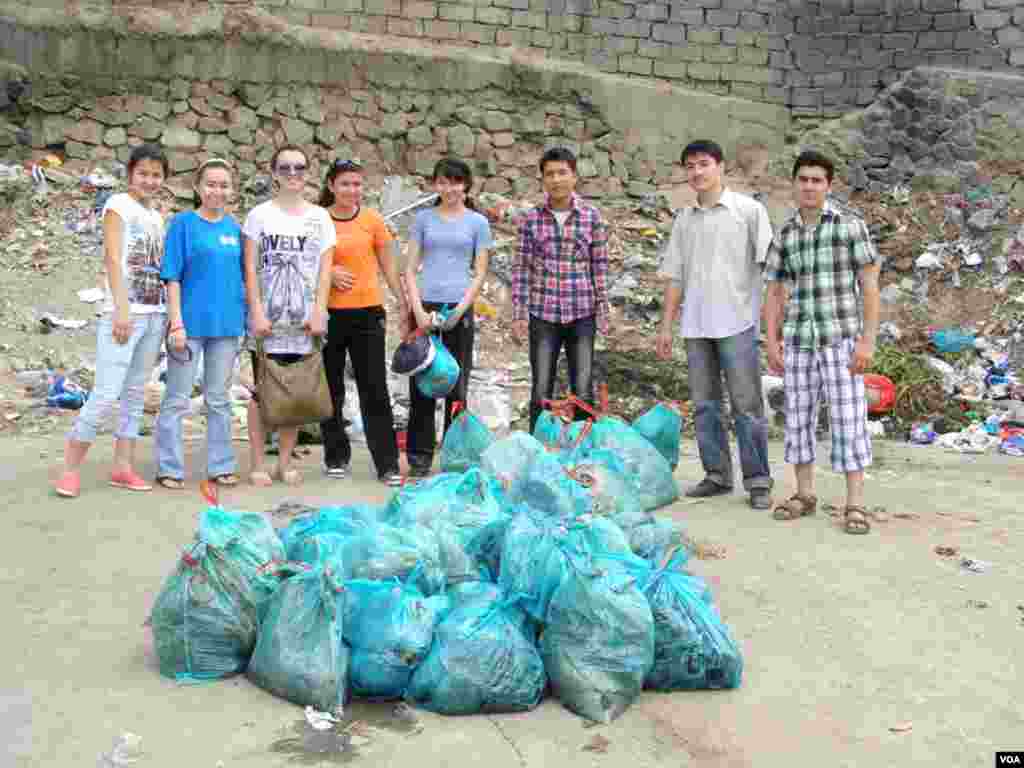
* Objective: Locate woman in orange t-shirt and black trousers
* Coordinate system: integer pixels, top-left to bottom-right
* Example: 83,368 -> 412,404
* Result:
319,160 -> 409,486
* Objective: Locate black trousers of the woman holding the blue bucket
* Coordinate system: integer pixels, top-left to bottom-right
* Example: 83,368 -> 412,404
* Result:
406,302 -> 476,470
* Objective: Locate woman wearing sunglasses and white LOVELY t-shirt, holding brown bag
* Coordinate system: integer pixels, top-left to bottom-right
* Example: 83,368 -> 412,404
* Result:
243,145 -> 335,485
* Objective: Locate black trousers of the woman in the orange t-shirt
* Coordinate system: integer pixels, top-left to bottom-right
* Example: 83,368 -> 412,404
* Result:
321,306 -> 398,475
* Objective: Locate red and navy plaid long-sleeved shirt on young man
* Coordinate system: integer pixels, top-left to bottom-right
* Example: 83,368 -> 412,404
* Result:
512,195 -> 608,324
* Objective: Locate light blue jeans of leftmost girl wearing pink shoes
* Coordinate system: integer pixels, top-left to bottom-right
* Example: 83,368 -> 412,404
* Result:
68,312 -> 167,442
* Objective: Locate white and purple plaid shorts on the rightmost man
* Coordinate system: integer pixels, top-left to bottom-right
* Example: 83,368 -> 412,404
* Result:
783,339 -> 871,473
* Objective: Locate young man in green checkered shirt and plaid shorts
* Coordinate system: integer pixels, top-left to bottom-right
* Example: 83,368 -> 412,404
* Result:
765,152 -> 881,534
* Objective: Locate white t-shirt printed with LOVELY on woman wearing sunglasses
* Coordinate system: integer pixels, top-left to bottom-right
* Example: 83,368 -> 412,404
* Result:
242,200 -> 336,354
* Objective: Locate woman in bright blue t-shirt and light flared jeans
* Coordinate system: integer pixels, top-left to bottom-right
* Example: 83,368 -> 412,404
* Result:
157,159 -> 246,488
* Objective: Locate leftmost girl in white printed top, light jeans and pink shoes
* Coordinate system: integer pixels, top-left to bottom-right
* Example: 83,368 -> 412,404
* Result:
55,144 -> 168,498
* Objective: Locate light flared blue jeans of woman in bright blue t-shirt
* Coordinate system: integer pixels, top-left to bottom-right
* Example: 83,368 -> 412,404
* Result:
157,336 -> 239,480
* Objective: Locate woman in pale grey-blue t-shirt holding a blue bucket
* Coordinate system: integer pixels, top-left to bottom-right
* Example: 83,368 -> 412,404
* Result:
406,158 -> 493,477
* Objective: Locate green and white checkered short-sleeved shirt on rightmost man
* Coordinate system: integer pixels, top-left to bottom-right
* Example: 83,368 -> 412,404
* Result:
764,202 -> 879,349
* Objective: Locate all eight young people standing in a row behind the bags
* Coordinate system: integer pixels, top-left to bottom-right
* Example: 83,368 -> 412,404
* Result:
49,140 -> 880,534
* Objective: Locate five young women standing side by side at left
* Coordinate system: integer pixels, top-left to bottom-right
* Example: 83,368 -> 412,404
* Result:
55,144 -> 492,498
